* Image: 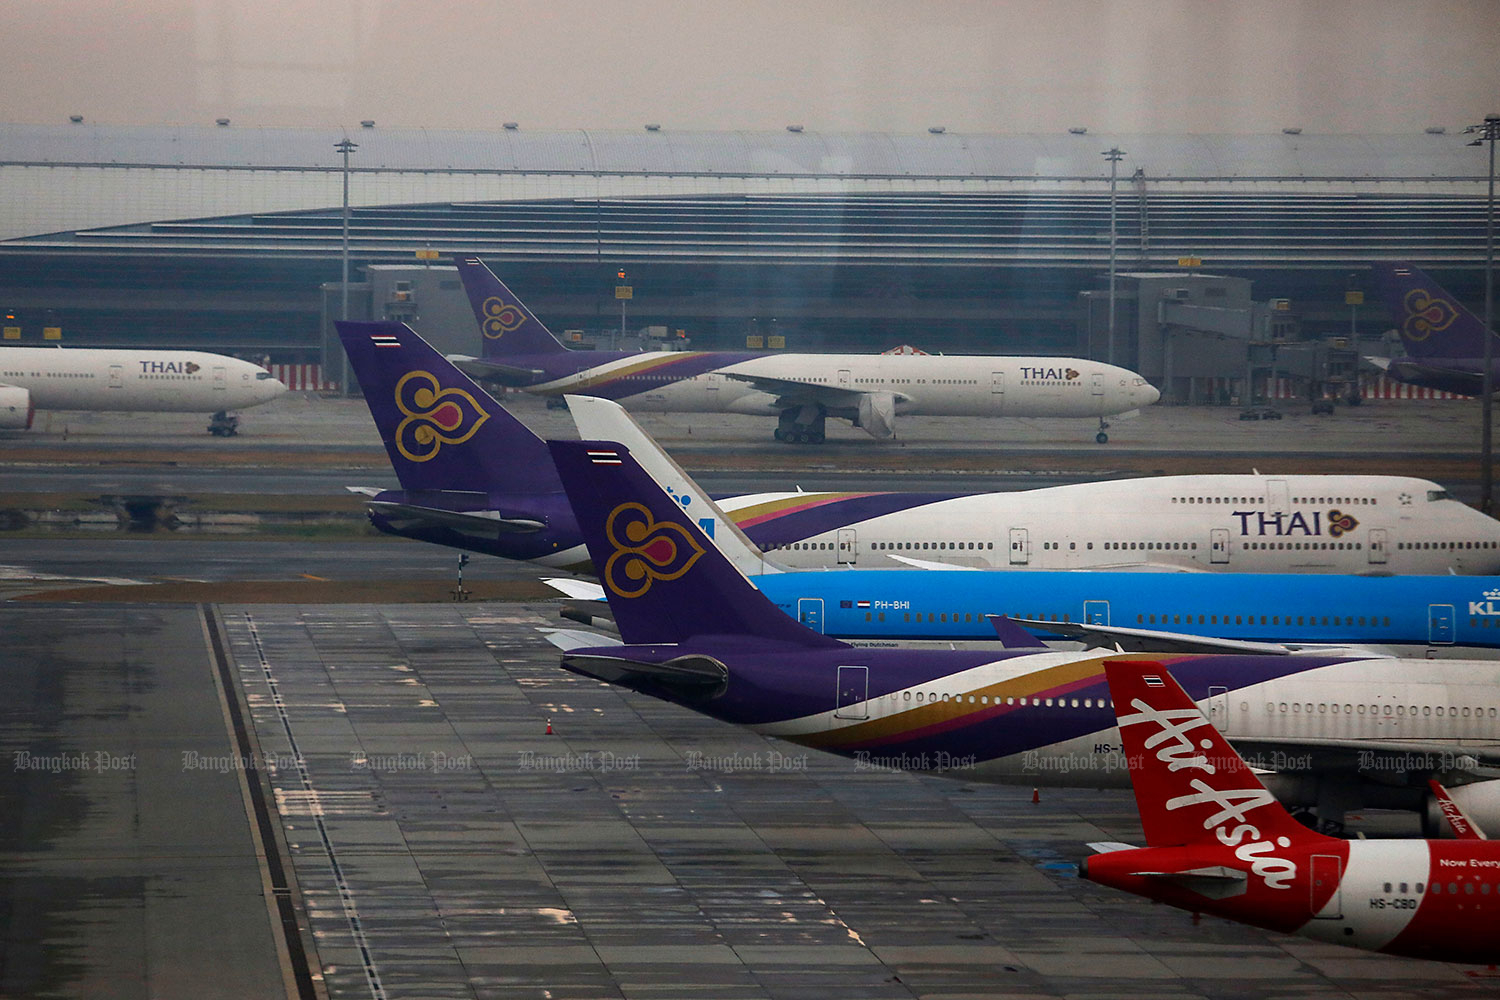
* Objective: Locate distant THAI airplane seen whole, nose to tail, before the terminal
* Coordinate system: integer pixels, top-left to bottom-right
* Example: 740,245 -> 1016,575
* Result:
455,256 -> 1161,444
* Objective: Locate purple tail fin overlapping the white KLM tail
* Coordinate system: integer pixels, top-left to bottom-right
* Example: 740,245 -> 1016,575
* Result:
548,441 -> 845,649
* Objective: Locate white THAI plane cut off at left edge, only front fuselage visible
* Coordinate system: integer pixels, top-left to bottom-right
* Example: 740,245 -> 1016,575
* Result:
0,346 -> 287,435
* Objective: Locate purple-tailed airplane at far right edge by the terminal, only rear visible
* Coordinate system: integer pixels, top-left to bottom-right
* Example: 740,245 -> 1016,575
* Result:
1365,261 -> 1500,396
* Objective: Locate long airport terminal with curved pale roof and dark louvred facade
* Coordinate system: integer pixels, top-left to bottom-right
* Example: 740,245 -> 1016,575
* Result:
0,121 -> 1488,396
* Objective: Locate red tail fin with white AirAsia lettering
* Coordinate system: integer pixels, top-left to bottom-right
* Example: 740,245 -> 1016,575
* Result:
1104,660 -> 1331,852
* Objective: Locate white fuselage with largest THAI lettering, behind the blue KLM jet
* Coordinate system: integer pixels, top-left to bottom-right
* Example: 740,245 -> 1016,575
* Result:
719,475 -> 1500,574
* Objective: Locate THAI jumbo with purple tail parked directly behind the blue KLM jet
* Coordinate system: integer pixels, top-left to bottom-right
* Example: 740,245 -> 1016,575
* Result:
339,322 -> 1500,574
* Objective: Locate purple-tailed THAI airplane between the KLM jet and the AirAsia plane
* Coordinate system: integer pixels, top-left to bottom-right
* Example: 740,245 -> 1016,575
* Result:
549,441 -> 1500,826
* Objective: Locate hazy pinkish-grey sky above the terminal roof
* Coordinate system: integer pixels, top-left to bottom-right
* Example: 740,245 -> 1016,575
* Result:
0,0 -> 1500,132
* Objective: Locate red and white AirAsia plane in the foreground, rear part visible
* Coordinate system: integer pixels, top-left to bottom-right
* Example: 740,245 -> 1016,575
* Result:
1080,661 -> 1500,964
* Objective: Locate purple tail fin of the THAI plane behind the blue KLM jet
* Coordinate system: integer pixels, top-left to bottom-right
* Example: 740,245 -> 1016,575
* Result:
336,322 -> 563,493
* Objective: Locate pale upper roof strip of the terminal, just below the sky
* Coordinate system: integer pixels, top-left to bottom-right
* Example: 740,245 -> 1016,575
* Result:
0,123 -> 1487,180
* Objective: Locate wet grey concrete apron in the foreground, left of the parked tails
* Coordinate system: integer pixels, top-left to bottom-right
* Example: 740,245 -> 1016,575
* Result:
0,604 -> 1485,997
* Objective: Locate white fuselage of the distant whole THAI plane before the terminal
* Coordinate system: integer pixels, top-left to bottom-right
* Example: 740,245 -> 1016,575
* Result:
530,352 -> 1161,417
